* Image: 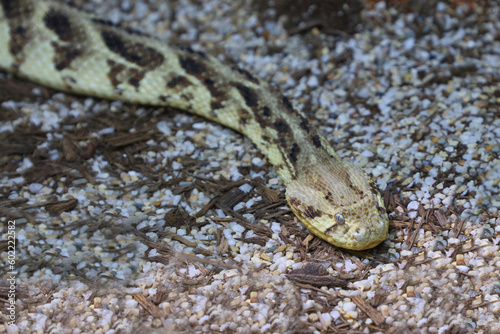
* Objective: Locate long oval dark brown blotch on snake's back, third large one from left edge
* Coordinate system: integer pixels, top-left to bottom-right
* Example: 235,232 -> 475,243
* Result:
101,30 -> 164,70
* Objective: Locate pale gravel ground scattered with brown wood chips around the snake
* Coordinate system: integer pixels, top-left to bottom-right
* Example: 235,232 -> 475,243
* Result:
0,0 -> 500,333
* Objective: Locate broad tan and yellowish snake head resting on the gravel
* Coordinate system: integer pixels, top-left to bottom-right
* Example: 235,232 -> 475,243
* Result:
286,160 -> 389,250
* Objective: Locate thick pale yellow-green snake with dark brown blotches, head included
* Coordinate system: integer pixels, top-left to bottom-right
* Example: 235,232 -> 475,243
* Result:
0,0 -> 389,250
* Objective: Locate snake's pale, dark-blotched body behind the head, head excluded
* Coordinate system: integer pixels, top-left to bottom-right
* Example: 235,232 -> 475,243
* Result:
0,0 -> 337,184
